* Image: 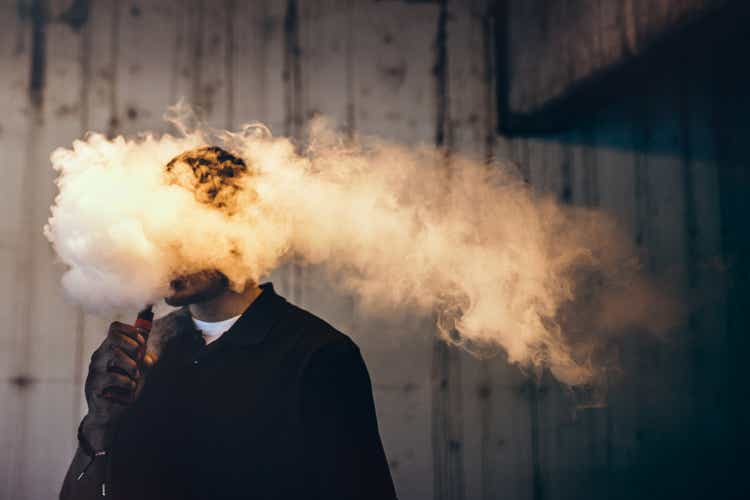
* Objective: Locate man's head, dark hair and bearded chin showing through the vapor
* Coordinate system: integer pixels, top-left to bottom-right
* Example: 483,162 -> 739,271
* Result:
164,146 -> 248,306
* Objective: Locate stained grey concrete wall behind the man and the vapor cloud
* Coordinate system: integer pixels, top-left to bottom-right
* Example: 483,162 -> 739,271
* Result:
0,0 -> 747,500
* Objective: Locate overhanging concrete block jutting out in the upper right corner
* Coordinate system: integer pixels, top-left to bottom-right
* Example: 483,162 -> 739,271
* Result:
500,0 -> 741,115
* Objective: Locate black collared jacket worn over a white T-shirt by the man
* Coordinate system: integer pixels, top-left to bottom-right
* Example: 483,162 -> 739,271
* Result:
68,284 -> 402,500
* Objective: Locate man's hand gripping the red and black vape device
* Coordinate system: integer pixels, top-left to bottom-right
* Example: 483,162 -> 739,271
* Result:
81,321 -> 154,450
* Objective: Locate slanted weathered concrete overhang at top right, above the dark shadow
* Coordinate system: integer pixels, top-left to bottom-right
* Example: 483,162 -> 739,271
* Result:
497,0 -> 748,132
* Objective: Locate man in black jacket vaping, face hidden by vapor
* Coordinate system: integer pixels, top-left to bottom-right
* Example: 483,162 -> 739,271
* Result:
60,148 -> 396,500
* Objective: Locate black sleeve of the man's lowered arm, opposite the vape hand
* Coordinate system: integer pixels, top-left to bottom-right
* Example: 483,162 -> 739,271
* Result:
302,338 -> 396,500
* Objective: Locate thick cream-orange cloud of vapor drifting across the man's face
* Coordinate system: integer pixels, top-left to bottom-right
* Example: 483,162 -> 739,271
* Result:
45,107 -> 679,384
